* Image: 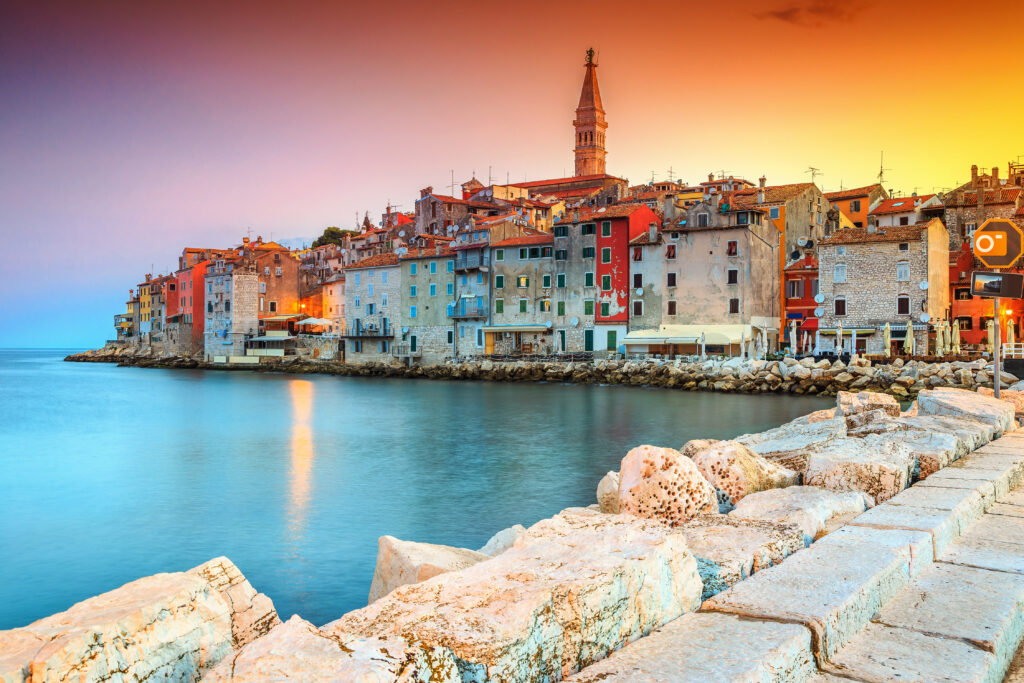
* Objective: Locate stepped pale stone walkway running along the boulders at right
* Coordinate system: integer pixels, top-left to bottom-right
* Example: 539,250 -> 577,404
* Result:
567,430 -> 1024,683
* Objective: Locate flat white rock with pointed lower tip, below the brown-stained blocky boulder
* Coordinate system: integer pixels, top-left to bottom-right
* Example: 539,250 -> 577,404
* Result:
729,486 -> 874,544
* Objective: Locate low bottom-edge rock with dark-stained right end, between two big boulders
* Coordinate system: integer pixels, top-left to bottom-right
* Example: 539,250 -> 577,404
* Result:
203,615 -> 461,683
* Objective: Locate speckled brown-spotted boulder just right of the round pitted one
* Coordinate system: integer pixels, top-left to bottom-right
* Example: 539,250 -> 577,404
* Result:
690,441 -> 800,505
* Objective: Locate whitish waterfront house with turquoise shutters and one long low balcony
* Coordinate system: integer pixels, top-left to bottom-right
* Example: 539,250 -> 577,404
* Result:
342,253 -> 401,364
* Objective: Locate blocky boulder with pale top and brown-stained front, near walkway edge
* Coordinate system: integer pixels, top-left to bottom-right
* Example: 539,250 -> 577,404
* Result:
804,434 -> 915,503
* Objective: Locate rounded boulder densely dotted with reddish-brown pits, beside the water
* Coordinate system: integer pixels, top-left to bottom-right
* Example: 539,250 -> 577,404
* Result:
618,445 -> 718,525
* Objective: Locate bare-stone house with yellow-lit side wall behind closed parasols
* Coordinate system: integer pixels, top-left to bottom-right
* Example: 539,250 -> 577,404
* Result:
818,219 -> 949,354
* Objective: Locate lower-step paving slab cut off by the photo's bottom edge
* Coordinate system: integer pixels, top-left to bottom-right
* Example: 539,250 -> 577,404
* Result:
827,624 -> 999,683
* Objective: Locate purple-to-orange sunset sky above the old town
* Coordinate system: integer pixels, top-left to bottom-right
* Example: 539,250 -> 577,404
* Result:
0,0 -> 1024,347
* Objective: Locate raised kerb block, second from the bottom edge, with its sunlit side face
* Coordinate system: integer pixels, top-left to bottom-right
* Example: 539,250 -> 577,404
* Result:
703,531 -> 931,661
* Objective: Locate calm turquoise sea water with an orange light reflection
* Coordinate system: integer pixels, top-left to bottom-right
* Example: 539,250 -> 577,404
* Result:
0,350 -> 826,629
